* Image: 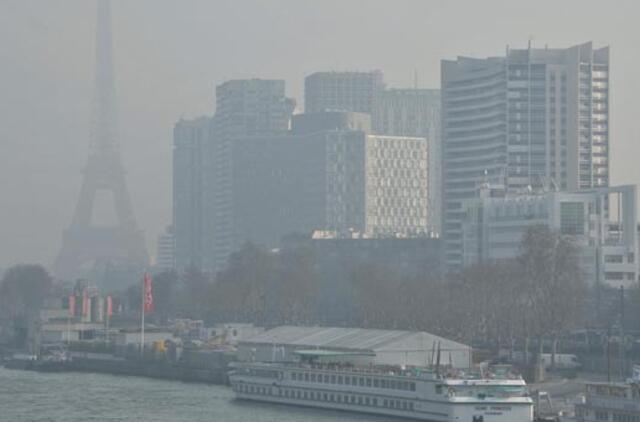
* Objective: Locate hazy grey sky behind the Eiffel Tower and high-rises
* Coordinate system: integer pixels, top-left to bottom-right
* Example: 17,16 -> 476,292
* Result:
0,0 -> 640,267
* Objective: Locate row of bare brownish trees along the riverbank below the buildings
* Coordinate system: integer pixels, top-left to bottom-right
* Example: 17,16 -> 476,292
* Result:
0,226 -> 640,356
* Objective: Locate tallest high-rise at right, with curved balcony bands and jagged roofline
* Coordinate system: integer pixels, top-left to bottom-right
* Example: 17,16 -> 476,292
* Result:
441,43 -> 609,269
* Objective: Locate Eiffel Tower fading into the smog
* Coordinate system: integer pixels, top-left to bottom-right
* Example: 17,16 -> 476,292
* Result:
54,0 -> 148,279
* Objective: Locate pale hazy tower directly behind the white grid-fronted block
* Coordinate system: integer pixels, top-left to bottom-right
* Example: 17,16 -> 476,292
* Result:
372,88 -> 442,233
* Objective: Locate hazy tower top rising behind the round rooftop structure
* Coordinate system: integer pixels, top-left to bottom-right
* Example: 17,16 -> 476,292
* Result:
304,70 -> 384,114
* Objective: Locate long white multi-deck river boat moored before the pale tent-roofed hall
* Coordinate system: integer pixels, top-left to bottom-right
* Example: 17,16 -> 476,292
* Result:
229,350 -> 533,422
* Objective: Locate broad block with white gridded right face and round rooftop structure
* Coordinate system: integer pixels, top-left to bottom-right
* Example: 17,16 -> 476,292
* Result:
234,113 -> 428,247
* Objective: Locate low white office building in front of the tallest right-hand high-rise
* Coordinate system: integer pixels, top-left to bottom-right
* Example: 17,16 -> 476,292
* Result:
462,185 -> 639,287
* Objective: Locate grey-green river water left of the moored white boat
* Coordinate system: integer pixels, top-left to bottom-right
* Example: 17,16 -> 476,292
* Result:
0,367 -> 399,422
